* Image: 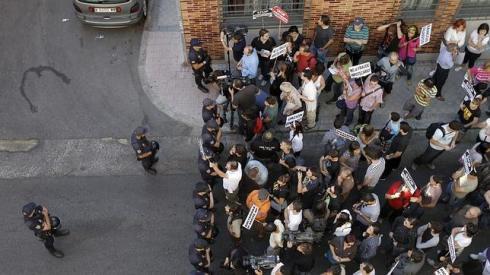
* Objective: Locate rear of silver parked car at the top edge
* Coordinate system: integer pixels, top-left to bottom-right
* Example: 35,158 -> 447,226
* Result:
73,0 -> 148,28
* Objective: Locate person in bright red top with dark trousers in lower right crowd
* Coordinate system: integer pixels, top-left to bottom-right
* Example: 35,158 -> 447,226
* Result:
381,180 -> 420,223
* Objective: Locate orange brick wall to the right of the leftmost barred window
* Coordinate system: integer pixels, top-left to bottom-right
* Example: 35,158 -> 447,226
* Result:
303,0 -> 461,55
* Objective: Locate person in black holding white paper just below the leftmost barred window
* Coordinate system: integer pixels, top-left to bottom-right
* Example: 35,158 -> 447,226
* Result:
252,29 -> 276,86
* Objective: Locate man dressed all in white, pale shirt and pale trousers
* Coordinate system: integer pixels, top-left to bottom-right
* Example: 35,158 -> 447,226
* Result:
301,69 -> 318,130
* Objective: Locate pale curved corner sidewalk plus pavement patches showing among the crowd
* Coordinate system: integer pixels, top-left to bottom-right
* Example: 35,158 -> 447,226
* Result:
138,0 -> 486,134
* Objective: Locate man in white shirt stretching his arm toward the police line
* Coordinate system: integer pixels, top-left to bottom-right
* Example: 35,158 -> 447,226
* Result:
209,161 -> 242,203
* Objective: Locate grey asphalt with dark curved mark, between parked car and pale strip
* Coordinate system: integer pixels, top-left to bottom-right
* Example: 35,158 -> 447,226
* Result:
0,0 -> 190,139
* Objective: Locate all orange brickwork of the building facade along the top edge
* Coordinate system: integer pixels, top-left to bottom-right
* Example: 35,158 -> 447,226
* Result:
180,0 -> 490,59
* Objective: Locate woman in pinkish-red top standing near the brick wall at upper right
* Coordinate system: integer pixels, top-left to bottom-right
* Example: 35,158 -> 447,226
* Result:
398,25 -> 420,85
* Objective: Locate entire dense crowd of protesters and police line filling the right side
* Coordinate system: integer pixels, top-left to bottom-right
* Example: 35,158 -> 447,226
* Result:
189,15 -> 490,275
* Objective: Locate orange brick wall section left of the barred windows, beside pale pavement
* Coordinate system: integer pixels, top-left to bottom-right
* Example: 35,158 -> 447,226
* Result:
180,0 -> 223,59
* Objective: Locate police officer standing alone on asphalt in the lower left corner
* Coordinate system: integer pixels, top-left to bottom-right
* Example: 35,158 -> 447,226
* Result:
22,202 -> 70,258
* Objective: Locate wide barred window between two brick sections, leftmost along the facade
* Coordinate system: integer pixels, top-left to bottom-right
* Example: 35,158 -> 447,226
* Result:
221,0 -> 309,28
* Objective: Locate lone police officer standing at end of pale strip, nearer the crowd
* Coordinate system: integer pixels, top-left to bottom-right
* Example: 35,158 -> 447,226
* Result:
131,126 -> 160,175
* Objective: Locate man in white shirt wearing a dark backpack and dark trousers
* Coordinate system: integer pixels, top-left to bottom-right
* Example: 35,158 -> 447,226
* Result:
412,121 -> 463,171
